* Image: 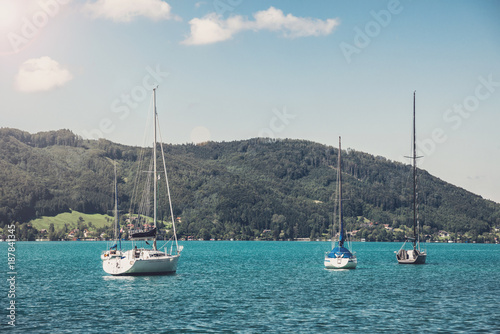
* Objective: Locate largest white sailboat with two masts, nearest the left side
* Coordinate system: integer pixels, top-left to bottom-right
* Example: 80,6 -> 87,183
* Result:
101,88 -> 183,276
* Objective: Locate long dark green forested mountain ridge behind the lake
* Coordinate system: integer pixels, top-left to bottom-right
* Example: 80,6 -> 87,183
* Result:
0,128 -> 500,240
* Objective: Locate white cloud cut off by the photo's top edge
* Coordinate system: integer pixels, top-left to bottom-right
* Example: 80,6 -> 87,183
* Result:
83,0 -> 180,22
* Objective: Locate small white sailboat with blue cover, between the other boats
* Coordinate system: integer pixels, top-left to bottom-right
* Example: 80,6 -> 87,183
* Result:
325,137 -> 358,269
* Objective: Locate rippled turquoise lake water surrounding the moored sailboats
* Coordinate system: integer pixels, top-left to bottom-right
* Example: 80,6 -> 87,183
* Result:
0,241 -> 500,333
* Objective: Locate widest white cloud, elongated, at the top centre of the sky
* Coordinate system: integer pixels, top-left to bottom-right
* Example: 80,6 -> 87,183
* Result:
182,7 -> 340,45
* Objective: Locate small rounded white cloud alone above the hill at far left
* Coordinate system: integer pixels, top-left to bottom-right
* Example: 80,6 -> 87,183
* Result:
15,57 -> 73,93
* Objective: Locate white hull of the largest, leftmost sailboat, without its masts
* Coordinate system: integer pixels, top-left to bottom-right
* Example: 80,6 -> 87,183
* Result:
102,249 -> 180,276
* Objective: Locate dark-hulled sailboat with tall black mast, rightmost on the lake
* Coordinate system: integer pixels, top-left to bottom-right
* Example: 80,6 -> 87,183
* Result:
394,92 -> 427,264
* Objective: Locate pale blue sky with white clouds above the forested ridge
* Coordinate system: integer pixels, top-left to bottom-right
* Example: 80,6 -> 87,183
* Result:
0,0 -> 500,202
